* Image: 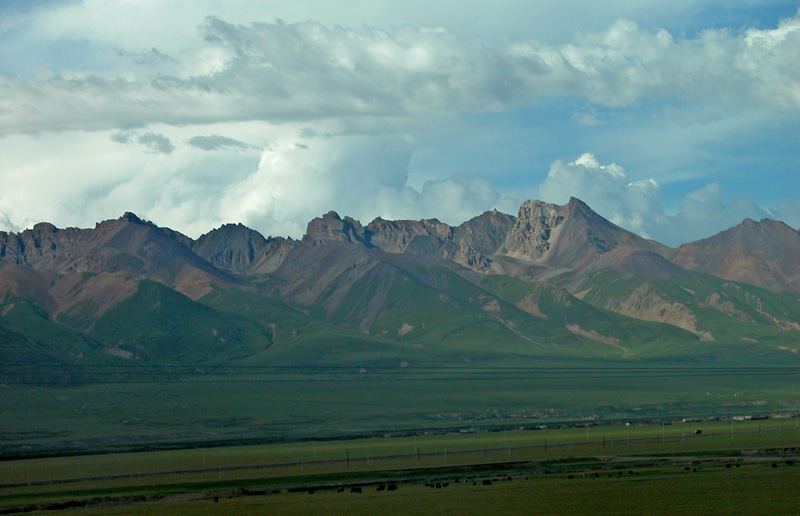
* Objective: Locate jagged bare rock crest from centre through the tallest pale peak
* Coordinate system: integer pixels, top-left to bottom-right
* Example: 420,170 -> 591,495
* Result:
302,198 -> 681,278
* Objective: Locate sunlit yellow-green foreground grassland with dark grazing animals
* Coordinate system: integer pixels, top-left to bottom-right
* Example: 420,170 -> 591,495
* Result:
0,418 -> 800,515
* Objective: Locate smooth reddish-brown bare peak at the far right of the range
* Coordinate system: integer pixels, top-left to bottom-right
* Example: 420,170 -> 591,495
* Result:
666,219 -> 800,292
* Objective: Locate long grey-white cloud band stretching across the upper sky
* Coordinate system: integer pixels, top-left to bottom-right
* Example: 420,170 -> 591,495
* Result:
0,16 -> 800,134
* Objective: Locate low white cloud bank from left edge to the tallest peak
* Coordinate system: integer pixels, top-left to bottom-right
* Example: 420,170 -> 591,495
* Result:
0,124 -> 523,237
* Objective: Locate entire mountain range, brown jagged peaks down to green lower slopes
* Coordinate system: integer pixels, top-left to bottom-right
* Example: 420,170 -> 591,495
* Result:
0,198 -> 800,383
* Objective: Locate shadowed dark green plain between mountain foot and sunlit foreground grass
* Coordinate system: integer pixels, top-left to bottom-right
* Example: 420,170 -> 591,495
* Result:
0,354 -> 800,456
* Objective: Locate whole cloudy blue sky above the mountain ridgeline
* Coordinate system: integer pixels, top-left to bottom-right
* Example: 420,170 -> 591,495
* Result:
0,0 -> 800,246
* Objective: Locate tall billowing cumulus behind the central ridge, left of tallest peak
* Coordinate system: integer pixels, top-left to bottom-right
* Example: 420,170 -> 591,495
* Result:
212,132 -> 521,237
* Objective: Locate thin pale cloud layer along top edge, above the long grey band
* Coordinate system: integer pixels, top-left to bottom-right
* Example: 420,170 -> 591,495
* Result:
18,0 -> 752,53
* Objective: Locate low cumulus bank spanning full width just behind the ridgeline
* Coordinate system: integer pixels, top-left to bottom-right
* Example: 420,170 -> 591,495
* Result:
0,125 -> 800,245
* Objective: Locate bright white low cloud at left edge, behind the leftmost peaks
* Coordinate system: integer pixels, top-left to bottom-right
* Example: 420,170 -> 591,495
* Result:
0,126 -> 258,236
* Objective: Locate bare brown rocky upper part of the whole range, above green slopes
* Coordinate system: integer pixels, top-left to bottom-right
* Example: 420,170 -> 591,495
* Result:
0,199 -> 800,362
